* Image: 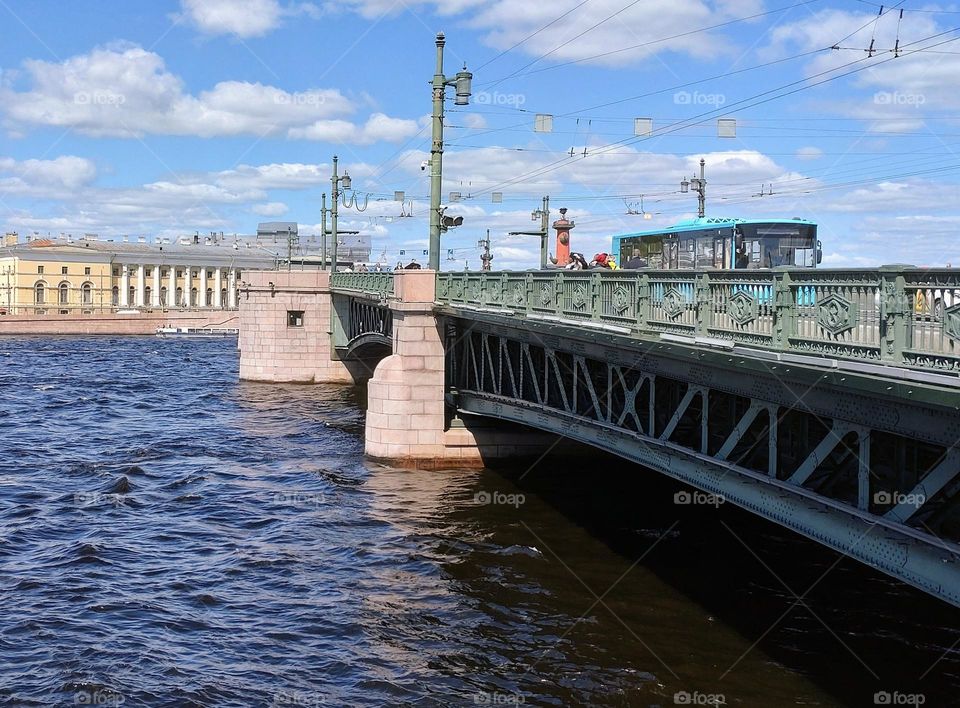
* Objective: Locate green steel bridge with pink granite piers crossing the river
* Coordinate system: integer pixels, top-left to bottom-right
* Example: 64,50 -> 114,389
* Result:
240,266 -> 960,606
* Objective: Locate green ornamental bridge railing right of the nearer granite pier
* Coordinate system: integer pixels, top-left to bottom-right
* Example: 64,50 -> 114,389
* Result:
437,266 -> 960,373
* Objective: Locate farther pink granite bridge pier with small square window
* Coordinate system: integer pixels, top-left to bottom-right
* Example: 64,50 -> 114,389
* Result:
239,270 -> 354,383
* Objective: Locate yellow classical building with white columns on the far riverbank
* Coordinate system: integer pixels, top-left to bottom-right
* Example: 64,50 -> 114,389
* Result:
0,234 -> 277,314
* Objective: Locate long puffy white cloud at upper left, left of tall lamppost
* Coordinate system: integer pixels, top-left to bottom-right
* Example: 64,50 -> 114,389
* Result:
0,45 -> 416,144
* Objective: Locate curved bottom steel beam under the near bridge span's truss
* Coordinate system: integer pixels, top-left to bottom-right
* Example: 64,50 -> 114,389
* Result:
458,391 -> 960,607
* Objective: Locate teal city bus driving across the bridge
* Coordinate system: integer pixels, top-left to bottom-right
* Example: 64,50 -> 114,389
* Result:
613,217 -> 821,270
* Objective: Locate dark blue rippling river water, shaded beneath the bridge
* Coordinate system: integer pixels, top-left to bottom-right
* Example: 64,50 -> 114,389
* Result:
0,337 -> 960,707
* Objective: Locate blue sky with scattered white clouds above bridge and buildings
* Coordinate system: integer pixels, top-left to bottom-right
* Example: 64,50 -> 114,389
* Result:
0,0 -> 960,268
